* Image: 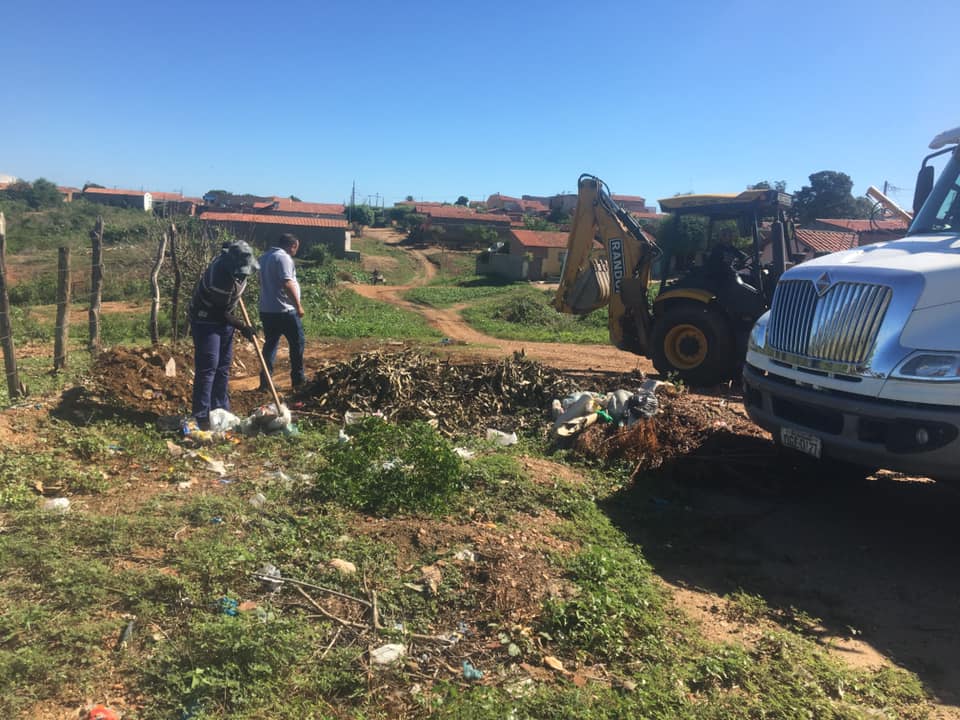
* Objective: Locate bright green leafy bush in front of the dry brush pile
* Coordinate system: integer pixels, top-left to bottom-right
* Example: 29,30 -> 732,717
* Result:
315,417 -> 462,515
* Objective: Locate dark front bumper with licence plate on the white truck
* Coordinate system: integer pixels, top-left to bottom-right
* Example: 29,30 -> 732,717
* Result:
743,364 -> 960,481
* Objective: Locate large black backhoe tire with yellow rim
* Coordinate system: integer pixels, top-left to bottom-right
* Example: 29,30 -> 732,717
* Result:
651,305 -> 737,387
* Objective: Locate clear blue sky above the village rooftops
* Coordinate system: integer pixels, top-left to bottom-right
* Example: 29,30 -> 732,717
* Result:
0,0 -> 960,206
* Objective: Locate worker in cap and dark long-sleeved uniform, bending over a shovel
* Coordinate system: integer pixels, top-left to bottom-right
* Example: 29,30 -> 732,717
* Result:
188,240 -> 260,430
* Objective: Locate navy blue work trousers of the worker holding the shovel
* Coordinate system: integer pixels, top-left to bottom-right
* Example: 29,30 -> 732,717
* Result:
190,321 -> 234,422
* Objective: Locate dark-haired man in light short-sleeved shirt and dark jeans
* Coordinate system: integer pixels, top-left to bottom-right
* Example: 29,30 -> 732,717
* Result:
260,233 -> 306,390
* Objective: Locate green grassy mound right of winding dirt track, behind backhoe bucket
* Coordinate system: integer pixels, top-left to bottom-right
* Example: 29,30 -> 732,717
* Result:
462,286 -> 610,344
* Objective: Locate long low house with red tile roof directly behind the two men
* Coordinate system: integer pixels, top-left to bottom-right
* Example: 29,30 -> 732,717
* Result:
200,211 -> 360,260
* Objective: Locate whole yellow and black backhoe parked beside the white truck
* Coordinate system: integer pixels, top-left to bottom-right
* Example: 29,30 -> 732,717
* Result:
554,175 -> 797,386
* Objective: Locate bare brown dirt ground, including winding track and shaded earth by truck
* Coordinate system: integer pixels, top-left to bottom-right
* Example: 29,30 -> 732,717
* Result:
9,235 -> 960,719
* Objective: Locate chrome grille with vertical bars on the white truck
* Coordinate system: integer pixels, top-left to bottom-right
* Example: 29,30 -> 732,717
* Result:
767,280 -> 893,364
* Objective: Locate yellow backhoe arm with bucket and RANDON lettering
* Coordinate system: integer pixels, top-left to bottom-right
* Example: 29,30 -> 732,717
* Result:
553,175 -> 660,355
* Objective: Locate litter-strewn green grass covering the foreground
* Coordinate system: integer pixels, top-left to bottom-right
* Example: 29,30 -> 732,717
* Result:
0,421 -> 929,720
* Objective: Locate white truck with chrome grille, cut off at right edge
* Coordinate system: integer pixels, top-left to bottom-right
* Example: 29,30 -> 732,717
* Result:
743,127 -> 960,481
